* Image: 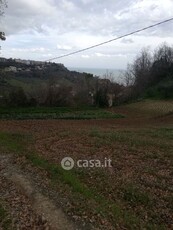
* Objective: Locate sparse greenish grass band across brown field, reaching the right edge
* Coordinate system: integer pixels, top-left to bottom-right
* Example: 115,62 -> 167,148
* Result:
88,128 -> 173,151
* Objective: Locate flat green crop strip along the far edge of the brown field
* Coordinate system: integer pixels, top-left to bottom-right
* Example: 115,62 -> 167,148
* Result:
0,107 -> 124,120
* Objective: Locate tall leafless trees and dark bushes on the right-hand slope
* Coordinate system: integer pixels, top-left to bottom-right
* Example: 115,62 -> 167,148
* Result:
125,44 -> 173,100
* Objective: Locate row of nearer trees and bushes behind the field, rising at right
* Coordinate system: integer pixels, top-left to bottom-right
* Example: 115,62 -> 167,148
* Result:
0,44 -> 173,107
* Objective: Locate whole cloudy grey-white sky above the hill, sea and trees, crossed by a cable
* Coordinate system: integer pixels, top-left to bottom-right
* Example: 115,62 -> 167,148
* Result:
0,0 -> 173,69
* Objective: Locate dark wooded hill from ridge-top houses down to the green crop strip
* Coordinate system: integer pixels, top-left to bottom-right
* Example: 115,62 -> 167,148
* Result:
0,58 -> 121,106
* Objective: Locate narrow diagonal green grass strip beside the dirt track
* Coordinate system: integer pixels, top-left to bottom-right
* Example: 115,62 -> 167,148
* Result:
27,153 -> 141,229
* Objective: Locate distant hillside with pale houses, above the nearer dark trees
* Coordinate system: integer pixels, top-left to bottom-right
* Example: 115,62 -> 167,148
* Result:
0,58 -> 95,92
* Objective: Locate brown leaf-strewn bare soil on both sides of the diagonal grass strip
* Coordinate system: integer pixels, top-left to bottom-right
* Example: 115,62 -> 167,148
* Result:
0,101 -> 173,230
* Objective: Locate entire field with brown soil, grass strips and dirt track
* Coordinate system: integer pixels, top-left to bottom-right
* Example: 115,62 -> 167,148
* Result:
0,101 -> 173,230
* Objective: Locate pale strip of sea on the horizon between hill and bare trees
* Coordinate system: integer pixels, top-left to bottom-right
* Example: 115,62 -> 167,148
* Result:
68,67 -> 125,82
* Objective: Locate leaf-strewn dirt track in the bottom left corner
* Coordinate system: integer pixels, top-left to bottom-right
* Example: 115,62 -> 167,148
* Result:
0,154 -> 78,230
